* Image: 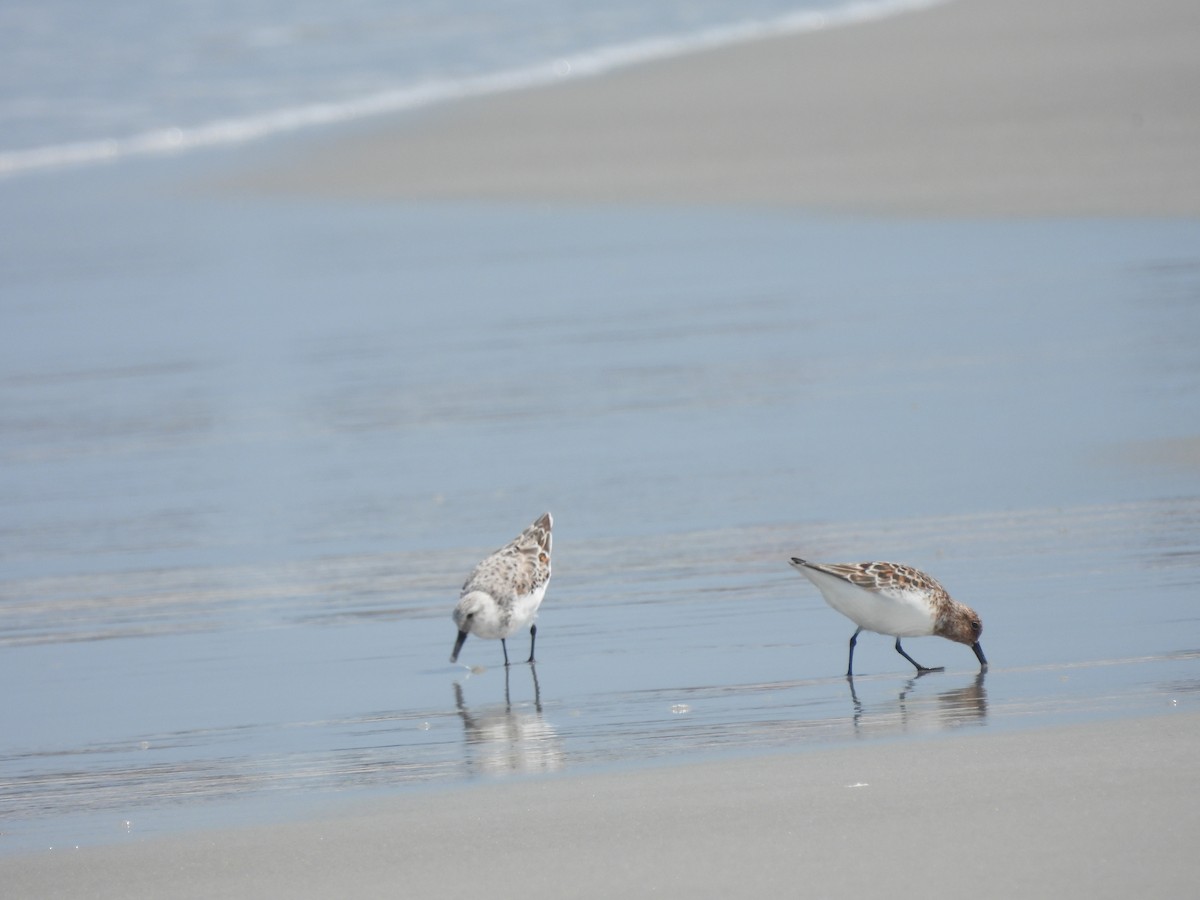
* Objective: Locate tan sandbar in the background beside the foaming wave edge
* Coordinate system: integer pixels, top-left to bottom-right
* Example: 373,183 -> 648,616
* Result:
251,0 -> 1200,216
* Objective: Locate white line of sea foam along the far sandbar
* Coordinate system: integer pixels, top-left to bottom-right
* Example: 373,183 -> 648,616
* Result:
0,0 -> 950,178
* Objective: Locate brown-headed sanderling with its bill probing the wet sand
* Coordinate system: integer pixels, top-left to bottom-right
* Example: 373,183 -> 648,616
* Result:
792,557 -> 988,677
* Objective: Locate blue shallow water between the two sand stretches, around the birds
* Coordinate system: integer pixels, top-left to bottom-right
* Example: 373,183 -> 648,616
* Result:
0,163 -> 1200,852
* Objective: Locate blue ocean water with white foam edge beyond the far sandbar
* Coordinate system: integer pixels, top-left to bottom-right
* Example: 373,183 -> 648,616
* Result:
0,0 -> 944,176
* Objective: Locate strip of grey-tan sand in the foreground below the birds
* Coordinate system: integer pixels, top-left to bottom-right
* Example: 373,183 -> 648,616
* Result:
0,712 -> 1200,900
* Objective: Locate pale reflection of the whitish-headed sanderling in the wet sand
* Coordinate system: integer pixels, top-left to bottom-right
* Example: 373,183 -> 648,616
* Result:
454,666 -> 565,775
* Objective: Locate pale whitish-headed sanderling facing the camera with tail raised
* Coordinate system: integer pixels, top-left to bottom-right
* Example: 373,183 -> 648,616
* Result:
450,512 -> 554,666
